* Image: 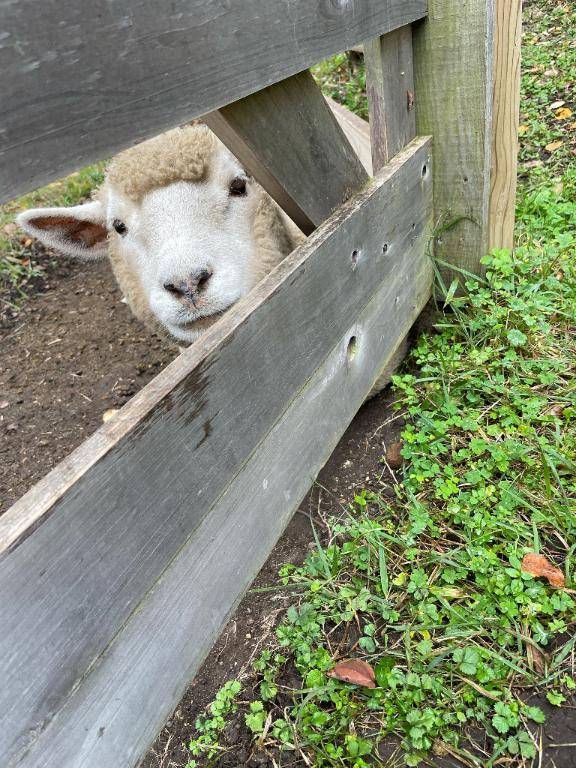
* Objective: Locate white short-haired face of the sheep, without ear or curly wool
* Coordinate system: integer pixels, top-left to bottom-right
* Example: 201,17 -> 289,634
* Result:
106,150 -> 260,343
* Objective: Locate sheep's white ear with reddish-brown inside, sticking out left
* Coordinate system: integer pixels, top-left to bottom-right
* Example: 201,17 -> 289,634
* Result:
16,200 -> 107,260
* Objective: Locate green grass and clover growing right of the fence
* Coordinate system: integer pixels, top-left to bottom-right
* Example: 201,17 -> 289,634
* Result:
191,0 -> 576,768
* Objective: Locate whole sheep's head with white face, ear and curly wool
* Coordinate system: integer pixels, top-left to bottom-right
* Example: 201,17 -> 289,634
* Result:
19,128 -> 262,345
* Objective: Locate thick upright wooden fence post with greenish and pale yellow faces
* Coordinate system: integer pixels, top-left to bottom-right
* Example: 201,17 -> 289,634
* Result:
414,0 -> 520,280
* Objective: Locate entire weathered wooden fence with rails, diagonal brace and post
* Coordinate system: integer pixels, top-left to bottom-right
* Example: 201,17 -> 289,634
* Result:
0,0 -> 517,768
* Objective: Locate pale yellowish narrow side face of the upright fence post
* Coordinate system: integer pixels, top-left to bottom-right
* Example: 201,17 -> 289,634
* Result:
488,0 -> 522,250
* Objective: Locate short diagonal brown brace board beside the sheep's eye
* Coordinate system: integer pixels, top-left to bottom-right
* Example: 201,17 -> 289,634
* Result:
204,71 -> 368,234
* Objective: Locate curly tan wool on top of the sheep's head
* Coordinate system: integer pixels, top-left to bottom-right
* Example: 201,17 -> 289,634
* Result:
106,125 -> 218,202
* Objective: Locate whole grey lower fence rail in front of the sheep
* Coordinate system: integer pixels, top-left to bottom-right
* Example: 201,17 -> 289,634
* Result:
0,138 -> 432,768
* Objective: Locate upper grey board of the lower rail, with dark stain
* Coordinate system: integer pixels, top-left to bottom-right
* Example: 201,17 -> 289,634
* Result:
0,139 -> 432,765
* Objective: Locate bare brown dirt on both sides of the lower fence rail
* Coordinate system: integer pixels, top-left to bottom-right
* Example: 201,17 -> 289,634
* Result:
0,251 -> 576,768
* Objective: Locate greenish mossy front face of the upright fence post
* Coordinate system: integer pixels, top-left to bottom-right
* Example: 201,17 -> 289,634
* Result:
413,0 -> 494,280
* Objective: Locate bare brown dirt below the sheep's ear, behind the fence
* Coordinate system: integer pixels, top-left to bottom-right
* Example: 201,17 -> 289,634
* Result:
0,251 -> 175,514
